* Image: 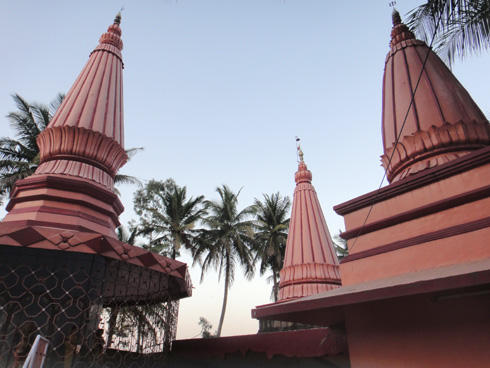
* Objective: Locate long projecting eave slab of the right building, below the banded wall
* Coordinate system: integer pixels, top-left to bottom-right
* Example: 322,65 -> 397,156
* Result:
252,259 -> 490,326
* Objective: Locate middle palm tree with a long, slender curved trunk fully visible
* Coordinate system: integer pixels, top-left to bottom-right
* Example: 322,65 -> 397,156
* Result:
194,185 -> 253,337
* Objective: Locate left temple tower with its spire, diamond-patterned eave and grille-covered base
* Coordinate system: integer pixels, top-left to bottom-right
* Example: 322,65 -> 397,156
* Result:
0,14 -> 192,368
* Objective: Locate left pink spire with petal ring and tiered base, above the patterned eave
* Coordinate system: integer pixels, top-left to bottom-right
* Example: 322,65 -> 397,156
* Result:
4,13 -> 127,237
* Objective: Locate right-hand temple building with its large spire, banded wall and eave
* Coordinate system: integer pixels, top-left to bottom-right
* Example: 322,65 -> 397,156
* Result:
252,11 -> 490,368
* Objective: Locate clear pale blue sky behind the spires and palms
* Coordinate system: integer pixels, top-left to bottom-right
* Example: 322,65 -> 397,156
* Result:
0,0 -> 490,339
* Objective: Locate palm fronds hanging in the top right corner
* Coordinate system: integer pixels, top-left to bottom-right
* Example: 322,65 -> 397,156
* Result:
407,0 -> 490,65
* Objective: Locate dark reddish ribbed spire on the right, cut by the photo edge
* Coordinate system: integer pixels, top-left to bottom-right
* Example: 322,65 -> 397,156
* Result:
381,11 -> 490,182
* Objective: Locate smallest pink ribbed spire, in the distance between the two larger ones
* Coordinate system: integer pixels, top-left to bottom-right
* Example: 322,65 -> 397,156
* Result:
279,151 -> 341,301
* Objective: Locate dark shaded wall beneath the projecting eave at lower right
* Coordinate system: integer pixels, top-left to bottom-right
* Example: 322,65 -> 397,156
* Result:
345,289 -> 490,368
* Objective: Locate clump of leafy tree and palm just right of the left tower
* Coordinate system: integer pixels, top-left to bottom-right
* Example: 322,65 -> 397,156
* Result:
134,179 -> 206,259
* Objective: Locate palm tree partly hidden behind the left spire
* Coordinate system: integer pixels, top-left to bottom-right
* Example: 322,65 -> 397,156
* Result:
0,93 -> 142,203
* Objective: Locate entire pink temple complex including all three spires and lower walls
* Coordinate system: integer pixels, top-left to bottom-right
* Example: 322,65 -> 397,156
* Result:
0,5 -> 490,368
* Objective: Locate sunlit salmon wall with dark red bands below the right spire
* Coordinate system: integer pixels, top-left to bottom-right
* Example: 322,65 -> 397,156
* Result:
340,160 -> 490,286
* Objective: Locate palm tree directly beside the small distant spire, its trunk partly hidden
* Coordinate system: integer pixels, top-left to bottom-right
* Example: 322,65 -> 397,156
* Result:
253,193 -> 291,302
